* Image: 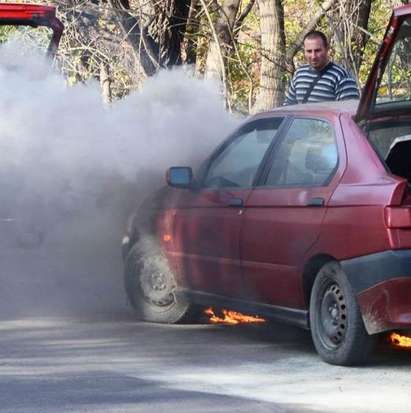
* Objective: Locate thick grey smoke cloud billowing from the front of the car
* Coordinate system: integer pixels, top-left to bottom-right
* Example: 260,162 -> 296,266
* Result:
0,46 -> 236,318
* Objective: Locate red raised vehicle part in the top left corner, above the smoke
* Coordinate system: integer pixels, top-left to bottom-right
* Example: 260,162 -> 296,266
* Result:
0,3 -> 64,56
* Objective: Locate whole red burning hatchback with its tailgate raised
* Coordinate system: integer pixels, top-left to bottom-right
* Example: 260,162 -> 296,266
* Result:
123,5 -> 411,365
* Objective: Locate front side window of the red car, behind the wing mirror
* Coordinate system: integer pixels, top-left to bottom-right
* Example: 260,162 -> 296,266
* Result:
203,118 -> 282,188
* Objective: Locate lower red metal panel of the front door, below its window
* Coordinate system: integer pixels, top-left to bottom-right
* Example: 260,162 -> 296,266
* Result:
167,189 -> 250,296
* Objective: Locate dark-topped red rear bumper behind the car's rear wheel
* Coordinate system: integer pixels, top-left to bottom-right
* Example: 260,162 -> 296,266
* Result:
341,250 -> 411,334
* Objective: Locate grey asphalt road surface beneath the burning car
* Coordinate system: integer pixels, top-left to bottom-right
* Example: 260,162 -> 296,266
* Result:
0,314 -> 411,413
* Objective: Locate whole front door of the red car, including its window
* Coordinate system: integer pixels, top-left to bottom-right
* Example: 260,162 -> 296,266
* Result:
174,118 -> 282,297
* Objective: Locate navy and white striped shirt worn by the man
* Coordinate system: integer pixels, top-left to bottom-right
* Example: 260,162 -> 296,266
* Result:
284,62 -> 359,105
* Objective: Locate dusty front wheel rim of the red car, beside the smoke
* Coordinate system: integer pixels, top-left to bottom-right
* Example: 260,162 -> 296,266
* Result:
140,259 -> 175,307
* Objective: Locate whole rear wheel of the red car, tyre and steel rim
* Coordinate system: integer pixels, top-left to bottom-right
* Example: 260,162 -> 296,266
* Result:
310,261 -> 375,366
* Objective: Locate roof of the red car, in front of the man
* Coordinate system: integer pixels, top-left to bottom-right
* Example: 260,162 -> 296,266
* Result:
257,99 -> 358,117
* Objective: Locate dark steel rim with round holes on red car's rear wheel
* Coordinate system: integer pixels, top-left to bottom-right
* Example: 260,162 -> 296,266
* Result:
320,283 -> 347,349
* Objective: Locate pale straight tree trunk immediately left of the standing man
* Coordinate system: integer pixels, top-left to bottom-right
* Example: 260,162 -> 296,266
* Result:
252,0 -> 285,113
